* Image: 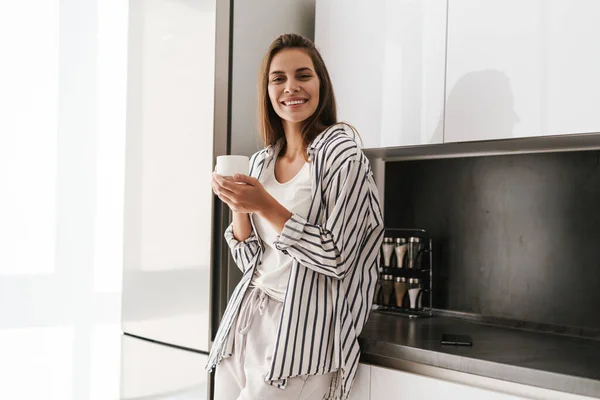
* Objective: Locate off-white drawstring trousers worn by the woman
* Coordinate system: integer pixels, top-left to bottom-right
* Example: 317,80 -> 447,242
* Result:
215,288 -> 333,400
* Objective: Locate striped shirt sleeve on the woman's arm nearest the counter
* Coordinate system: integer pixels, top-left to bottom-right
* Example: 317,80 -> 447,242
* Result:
274,160 -> 376,279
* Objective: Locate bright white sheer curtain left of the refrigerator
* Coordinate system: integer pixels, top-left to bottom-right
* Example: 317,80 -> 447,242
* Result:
0,0 -> 128,400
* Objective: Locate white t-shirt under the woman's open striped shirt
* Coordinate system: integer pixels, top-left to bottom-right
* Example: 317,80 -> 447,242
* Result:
250,163 -> 312,302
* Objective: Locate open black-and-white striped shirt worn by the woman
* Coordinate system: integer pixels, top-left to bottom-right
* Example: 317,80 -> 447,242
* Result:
207,124 -> 383,400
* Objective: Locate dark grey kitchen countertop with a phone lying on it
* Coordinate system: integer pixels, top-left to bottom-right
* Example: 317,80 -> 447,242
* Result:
359,312 -> 600,397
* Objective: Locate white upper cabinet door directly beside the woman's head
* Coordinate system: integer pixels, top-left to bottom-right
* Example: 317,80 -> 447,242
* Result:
315,0 -> 447,148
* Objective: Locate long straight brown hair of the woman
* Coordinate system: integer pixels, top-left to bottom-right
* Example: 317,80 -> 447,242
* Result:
258,33 -> 337,157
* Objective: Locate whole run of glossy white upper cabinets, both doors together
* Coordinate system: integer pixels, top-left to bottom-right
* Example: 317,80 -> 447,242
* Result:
315,0 -> 600,148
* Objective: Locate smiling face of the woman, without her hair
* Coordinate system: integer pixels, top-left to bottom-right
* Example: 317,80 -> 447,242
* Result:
268,49 -> 319,126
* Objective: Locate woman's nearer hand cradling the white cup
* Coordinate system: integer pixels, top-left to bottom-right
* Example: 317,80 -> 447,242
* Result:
213,172 -> 273,213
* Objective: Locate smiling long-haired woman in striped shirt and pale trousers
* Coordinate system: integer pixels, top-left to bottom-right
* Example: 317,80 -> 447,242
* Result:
207,34 -> 383,400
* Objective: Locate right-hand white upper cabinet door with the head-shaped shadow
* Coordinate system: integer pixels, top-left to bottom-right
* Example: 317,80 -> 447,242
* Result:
444,0 -> 600,142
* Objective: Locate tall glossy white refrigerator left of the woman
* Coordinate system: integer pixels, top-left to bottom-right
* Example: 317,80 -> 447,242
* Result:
121,0 -> 228,400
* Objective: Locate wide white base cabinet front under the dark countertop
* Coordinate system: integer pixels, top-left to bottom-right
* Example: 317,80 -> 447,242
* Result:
370,367 -> 525,400
